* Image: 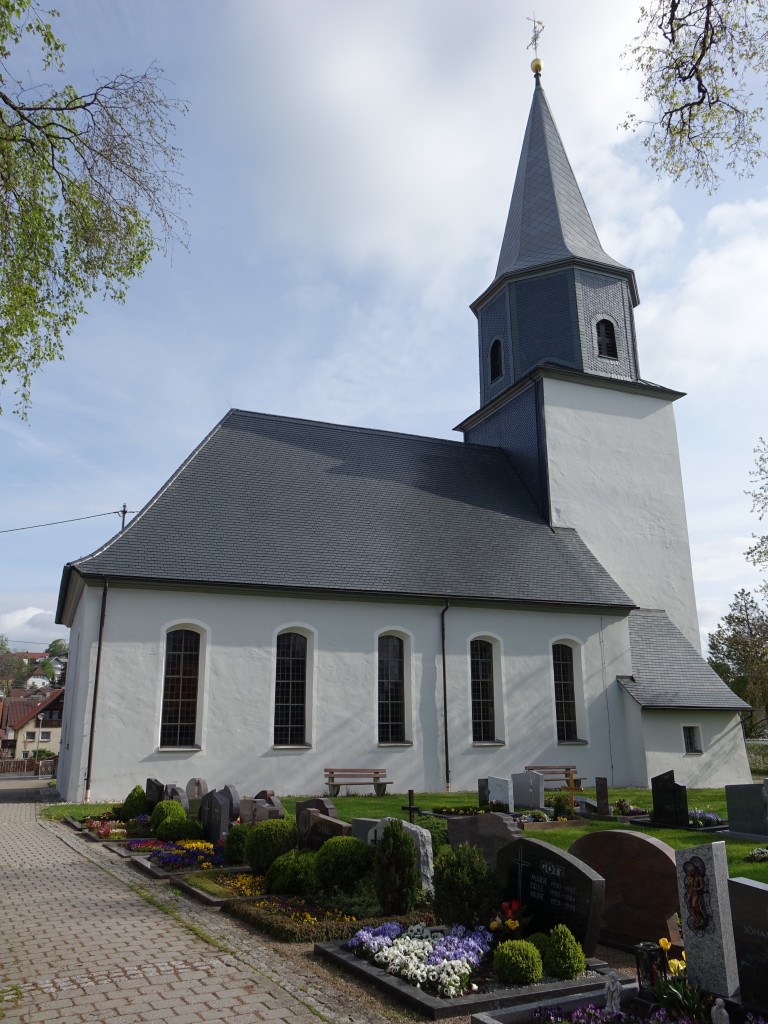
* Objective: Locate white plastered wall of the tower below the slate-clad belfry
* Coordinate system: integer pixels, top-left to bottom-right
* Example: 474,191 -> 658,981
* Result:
544,378 -> 700,650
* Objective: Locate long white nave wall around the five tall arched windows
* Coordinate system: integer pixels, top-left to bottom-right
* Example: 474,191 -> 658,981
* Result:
59,585 -> 655,801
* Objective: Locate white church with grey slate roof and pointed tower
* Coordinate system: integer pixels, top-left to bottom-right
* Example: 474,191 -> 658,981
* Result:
56,61 -> 751,802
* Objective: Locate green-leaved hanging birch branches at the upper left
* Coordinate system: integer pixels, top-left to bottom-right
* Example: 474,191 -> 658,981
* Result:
0,0 -> 186,417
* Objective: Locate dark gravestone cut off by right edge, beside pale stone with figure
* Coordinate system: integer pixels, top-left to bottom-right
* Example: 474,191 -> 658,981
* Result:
728,879 -> 768,1014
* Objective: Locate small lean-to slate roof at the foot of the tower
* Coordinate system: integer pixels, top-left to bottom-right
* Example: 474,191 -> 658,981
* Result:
618,608 -> 751,711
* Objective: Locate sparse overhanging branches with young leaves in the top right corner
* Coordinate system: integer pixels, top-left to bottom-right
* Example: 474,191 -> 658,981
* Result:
623,0 -> 768,193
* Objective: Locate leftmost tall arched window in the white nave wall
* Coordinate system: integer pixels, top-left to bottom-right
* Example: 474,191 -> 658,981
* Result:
160,630 -> 200,746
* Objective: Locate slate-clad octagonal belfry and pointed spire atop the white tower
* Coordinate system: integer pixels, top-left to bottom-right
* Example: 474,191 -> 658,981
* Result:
472,58 -> 639,406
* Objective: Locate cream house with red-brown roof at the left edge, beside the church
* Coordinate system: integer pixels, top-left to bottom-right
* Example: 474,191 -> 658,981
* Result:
0,688 -> 65,761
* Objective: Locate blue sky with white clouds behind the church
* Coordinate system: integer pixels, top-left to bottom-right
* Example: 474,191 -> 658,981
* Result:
0,0 -> 768,649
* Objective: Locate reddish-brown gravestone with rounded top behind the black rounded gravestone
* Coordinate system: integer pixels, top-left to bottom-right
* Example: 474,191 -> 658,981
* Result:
568,828 -> 681,949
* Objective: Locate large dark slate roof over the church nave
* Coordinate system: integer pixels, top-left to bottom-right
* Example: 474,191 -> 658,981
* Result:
57,410 -> 634,621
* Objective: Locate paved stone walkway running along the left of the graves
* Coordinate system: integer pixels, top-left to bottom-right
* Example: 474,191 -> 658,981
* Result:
0,803 -> 385,1024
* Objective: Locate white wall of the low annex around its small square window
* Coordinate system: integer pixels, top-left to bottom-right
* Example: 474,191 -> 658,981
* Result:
642,708 -> 752,788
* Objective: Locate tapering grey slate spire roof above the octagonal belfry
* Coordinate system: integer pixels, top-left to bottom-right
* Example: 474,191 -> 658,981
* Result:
496,76 -> 636,297
